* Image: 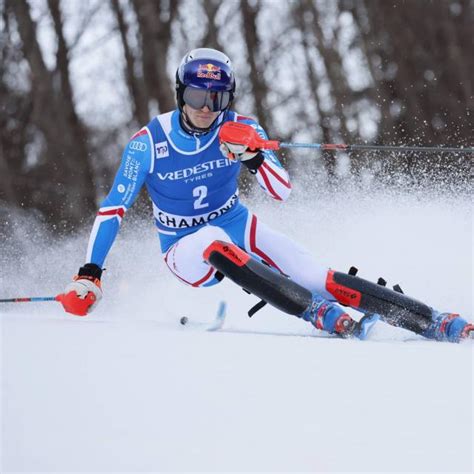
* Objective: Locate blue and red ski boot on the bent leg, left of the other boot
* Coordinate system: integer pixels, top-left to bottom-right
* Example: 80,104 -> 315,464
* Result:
300,293 -> 380,340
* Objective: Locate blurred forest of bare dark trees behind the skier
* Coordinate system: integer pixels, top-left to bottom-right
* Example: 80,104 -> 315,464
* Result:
0,0 -> 474,231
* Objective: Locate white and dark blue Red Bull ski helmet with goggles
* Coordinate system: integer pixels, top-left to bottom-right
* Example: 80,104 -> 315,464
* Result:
176,48 -> 235,133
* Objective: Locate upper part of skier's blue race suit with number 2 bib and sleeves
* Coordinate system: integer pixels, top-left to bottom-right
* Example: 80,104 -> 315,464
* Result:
87,110 -> 291,267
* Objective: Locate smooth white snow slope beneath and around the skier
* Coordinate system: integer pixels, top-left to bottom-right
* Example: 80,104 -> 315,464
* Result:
0,187 -> 473,472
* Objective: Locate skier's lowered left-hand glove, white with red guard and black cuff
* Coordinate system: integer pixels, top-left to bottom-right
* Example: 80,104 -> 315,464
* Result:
58,263 -> 102,316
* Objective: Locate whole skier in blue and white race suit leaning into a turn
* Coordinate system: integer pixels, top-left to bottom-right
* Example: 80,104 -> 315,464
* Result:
60,48 -> 474,341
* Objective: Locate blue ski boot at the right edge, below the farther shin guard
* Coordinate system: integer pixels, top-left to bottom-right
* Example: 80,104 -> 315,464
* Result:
422,311 -> 474,342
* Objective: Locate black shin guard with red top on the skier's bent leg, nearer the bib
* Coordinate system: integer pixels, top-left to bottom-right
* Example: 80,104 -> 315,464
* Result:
204,240 -> 312,316
